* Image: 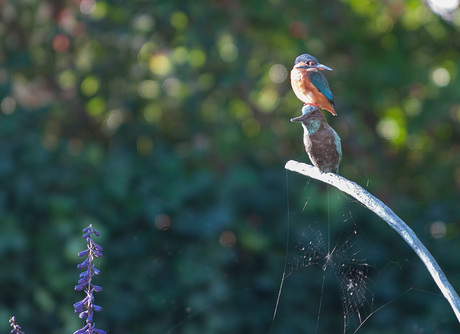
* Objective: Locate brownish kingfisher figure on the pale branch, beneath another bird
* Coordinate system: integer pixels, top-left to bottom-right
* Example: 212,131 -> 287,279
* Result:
291,104 -> 342,174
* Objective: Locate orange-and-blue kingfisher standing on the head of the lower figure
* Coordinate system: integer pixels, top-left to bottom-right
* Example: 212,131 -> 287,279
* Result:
291,54 -> 337,116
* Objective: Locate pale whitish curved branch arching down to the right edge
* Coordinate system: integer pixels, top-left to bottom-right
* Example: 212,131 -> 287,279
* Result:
285,160 -> 460,322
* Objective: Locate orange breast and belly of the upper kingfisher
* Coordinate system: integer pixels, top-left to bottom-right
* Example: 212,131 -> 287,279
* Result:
291,68 -> 337,115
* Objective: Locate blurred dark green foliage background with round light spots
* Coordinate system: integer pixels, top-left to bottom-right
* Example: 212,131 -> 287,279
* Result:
0,0 -> 460,334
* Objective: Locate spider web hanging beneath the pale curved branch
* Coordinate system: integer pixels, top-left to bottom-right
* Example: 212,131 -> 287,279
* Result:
273,179 -> 404,334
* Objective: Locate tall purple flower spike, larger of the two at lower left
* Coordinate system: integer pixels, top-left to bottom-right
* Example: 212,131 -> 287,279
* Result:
73,225 -> 106,334
